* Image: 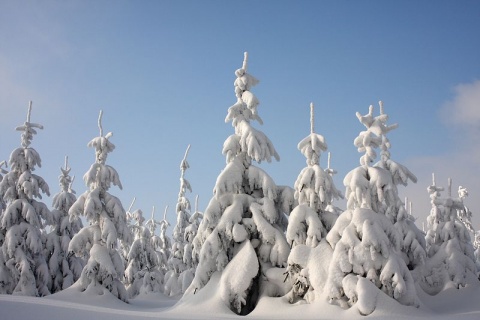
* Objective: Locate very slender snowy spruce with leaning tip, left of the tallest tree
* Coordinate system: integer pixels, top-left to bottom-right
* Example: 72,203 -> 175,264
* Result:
165,145 -> 193,296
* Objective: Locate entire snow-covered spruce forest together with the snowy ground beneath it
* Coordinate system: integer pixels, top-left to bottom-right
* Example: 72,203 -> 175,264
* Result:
0,53 -> 480,319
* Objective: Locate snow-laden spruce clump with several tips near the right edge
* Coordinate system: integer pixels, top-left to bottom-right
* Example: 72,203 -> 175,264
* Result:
422,175 -> 477,294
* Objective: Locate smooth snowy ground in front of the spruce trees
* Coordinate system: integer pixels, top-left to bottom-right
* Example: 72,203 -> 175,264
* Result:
0,272 -> 480,320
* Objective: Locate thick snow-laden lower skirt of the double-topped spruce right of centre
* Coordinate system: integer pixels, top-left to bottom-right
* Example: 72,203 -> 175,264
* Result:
326,208 -> 418,307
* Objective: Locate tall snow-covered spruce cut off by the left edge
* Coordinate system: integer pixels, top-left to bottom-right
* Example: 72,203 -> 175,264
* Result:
0,102 -> 51,296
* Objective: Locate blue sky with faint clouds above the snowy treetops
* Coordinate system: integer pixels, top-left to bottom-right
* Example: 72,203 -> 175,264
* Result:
0,0 -> 480,229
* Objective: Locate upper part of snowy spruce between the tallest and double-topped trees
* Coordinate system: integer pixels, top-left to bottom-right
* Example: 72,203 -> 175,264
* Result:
287,103 -> 343,247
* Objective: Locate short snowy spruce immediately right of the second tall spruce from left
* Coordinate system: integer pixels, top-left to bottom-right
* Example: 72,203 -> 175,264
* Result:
125,205 -> 163,298
